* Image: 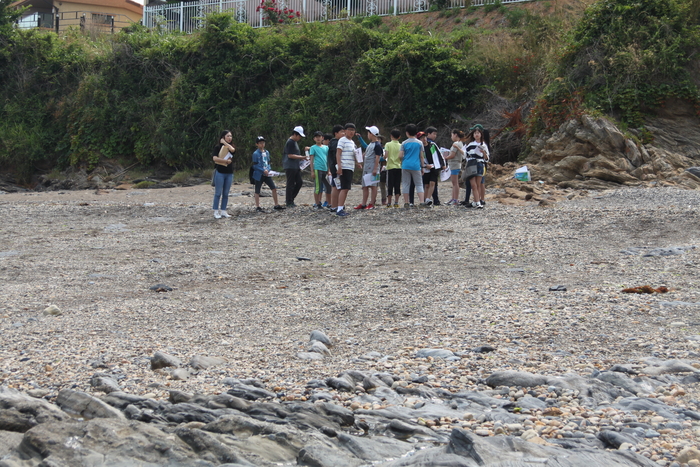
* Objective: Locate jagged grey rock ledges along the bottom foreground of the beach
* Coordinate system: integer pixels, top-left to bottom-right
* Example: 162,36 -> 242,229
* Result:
0,362 -> 700,467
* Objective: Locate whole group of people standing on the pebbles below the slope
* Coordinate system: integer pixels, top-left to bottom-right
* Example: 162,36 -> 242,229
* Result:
212,123 -> 490,219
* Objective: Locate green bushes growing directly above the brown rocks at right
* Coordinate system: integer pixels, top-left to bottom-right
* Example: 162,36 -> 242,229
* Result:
531,0 -> 700,132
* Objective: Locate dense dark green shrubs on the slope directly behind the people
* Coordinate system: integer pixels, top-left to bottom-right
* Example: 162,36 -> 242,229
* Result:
0,14 -> 482,181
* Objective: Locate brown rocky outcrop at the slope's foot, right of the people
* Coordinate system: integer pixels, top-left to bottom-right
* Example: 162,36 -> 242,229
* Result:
526,103 -> 700,189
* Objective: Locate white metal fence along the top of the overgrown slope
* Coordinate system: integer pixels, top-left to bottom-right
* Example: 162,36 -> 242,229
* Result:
143,0 -> 530,33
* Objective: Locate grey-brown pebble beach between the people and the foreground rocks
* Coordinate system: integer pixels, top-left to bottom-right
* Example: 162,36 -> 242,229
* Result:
0,185 -> 700,467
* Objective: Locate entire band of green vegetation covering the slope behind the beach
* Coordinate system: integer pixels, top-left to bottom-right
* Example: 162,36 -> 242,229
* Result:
0,0 -> 700,180
